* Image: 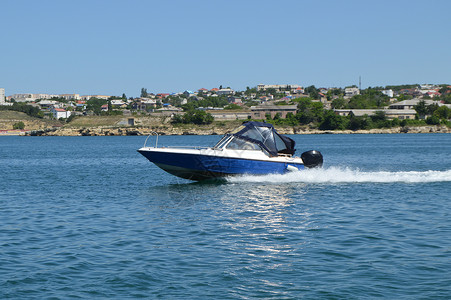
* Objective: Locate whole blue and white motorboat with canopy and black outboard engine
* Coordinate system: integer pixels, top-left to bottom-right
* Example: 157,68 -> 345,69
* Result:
138,121 -> 323,181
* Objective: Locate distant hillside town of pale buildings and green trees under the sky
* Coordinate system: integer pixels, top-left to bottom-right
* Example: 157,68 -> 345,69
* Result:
0,84 -> 451,130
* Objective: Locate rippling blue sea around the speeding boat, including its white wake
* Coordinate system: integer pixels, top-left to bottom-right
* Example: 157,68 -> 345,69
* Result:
0,134 -> 451,299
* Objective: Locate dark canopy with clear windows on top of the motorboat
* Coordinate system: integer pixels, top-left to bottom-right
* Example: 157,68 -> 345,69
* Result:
232,122 -> 296,156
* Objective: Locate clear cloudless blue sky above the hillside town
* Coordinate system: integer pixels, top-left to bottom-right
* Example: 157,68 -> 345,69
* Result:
0,0 -> 451,97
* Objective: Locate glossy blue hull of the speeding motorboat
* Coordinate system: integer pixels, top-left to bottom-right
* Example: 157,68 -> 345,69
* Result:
138,151 -> 304,181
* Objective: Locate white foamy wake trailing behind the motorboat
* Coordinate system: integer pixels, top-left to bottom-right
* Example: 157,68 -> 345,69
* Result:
227,167 -> 451,183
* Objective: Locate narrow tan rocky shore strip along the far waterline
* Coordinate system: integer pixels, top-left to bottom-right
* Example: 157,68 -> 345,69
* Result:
25,126 -> 451,136
